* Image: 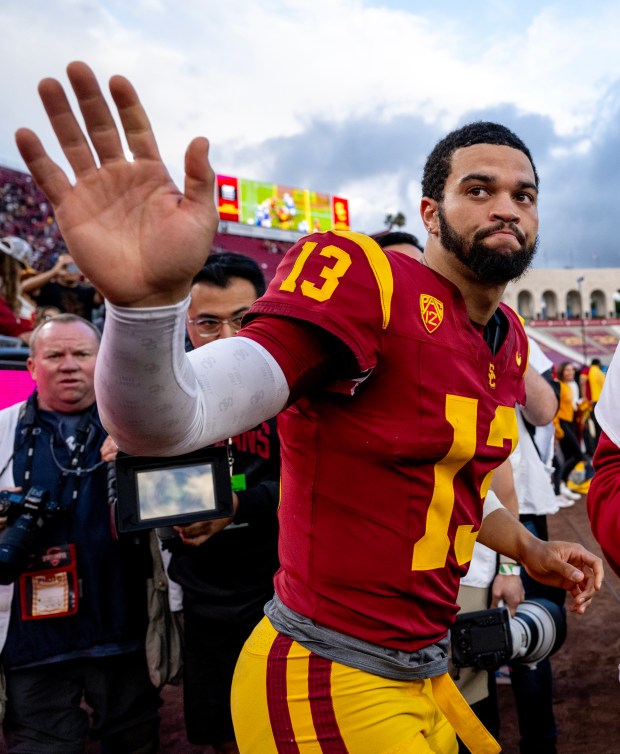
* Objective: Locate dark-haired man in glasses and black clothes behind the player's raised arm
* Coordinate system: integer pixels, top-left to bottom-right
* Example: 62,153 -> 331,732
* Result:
169,252 -> 280,754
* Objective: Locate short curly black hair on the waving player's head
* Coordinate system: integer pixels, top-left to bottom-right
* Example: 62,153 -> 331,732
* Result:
422,121 -> 538,202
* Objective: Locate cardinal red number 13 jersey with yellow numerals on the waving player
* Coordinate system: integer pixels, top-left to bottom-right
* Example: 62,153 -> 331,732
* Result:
245,232 -> 528,651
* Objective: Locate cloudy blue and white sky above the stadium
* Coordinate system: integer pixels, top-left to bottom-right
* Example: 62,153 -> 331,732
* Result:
0,0 -> 620,267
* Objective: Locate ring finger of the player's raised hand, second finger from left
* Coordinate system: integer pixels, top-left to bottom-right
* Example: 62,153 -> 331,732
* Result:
39,79 -> 96,176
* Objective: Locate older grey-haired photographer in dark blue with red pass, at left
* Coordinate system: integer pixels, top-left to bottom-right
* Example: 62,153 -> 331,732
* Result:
0,314 -> 159,754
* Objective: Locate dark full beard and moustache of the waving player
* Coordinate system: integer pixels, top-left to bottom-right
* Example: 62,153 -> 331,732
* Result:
437,206 -> 538,285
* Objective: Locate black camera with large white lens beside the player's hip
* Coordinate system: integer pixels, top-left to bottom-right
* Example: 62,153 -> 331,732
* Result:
451,597 -> 566,670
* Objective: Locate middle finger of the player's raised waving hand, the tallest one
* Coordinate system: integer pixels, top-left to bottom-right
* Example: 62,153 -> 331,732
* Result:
67,62 -> 125,165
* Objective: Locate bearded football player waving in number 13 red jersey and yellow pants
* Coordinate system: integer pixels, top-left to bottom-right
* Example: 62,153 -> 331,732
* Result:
17,63 -> 602,754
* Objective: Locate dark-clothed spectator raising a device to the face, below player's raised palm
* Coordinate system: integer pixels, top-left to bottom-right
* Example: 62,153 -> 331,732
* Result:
22,254 -> 103,322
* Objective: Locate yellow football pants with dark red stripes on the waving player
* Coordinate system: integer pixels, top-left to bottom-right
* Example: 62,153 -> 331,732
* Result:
232,618 -> 500,754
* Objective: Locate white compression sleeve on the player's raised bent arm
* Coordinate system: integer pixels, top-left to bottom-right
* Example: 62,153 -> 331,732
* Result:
96,299 -> 289,456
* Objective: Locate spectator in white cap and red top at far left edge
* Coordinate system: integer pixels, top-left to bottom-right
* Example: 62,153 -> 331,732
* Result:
0,236 -> 32,343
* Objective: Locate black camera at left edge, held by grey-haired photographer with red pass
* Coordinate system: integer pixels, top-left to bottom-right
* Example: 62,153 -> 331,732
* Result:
0,487 -> 59,584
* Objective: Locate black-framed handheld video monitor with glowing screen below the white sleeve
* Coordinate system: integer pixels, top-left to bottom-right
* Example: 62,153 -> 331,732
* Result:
116,447 -> 233,532
